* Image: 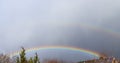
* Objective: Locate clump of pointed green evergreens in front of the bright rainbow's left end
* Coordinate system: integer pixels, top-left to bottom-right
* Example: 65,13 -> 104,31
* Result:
16,47 -> 40,63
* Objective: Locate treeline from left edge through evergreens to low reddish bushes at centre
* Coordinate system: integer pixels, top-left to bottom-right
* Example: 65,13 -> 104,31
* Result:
0,47 -> 73,63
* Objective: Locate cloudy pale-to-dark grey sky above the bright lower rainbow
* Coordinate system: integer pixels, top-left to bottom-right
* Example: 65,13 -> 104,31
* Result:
0,0 -> 120,58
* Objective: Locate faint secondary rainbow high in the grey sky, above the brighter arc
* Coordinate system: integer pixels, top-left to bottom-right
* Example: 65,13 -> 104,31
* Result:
34,20 -> 120,38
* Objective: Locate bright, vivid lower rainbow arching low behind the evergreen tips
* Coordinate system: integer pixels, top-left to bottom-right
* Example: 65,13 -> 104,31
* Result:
9,46 -> 102,58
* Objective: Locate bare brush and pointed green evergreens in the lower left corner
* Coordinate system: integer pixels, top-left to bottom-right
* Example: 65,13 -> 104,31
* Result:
0,47 -> 40,63
